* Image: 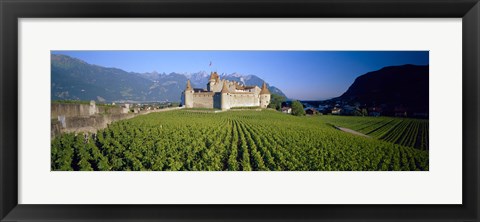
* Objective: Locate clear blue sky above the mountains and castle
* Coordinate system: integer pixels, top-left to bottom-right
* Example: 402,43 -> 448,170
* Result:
52,51 -> 429,100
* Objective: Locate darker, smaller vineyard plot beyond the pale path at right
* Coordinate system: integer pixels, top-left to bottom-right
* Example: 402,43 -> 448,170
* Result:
322,116 -> 428,150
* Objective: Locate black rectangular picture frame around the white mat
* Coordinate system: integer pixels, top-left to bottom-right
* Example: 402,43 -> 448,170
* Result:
0,0 -> 480,221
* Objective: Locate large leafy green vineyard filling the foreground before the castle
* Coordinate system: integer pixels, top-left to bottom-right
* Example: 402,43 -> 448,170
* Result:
51,111 -> 429,171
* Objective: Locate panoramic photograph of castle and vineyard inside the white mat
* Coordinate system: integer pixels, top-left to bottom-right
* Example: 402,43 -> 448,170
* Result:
50,50 -> 429,171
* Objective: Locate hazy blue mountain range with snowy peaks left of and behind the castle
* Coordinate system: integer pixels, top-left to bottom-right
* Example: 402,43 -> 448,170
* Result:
51,54 -> 285,102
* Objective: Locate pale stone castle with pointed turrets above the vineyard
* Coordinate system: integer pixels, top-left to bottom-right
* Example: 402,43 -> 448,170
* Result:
182,72 -> 270,110
